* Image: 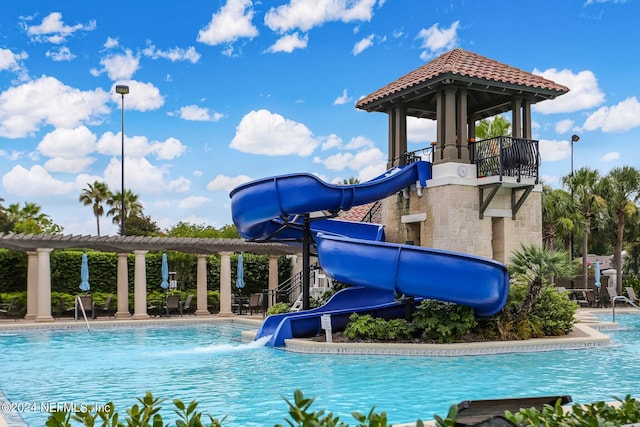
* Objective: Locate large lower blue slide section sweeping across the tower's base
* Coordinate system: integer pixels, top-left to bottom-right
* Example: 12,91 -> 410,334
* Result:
315,233 -> 509,317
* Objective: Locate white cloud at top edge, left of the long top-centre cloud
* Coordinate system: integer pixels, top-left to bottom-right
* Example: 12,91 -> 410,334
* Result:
197,0 -> 258,46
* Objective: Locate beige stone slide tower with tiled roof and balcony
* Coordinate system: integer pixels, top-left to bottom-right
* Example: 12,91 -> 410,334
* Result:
356,49 -> 569,262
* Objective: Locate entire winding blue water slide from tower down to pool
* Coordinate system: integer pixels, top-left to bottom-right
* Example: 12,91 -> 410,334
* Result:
230,162 -> 509,347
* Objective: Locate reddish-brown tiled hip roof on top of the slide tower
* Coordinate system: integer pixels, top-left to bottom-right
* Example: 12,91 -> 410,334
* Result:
356,48 -> 569,109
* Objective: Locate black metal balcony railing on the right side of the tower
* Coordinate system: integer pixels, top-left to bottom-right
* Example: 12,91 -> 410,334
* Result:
469,136 -> 540,184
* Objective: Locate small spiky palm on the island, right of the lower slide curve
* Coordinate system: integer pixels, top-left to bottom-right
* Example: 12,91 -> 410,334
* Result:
509,245 -> 573,323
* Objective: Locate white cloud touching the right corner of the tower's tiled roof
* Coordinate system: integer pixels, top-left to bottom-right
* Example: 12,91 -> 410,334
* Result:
533,68 -> 604,114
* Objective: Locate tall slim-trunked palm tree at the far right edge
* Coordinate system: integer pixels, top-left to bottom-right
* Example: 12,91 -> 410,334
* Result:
600,166 -> 640,292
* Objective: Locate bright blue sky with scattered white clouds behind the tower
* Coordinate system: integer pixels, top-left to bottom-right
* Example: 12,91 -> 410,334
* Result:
0,0 -> 640,235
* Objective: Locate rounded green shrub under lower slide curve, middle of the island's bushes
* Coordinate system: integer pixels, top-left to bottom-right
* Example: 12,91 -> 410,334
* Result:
413,300 -> 478,343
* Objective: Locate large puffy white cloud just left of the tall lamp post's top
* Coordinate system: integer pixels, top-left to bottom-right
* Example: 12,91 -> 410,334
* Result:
0,76 -> 109,138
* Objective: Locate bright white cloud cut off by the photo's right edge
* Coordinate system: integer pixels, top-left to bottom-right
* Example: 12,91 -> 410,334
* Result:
582,96 -> 640,132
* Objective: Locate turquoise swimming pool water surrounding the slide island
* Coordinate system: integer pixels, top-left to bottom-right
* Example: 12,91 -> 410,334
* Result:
0,314 -> 640,427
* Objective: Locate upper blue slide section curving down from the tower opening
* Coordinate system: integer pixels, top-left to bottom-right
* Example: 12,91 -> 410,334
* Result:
230,162 -> 431,240
